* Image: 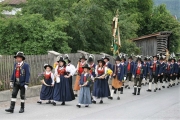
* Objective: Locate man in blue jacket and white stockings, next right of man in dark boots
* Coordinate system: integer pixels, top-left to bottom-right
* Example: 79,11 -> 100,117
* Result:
147,55 -> 160,92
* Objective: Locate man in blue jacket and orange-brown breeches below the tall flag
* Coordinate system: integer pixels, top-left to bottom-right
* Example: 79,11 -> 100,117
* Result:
108,56 -> 125,100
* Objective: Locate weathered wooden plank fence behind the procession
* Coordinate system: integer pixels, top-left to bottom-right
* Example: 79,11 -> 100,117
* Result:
0,53 -> 114,91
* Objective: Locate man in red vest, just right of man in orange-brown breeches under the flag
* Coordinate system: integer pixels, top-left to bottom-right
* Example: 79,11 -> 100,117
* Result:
125,56 -> 134,89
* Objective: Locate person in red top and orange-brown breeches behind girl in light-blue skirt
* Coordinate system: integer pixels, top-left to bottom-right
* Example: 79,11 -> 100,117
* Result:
74,55 -> 87,97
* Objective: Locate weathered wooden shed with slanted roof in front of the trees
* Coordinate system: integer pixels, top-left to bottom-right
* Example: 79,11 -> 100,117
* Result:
132,31 -> 171,56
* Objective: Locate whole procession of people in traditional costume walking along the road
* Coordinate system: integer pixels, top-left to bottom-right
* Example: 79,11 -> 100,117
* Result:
5,52 -> 180,113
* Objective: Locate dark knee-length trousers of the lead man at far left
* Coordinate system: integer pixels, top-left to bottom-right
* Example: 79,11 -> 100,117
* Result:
12,83 -> 25,100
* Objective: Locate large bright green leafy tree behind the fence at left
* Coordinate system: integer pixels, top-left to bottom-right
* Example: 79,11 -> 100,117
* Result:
0,14 -> 71,54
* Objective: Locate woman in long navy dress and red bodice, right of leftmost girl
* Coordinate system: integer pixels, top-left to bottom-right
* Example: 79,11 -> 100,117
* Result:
53,57 -> 75,106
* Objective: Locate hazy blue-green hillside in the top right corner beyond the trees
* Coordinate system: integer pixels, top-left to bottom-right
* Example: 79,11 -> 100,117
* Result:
154,0 -> 180,19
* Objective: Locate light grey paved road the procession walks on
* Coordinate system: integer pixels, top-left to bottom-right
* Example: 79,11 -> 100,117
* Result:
0,85 -> 180,120
